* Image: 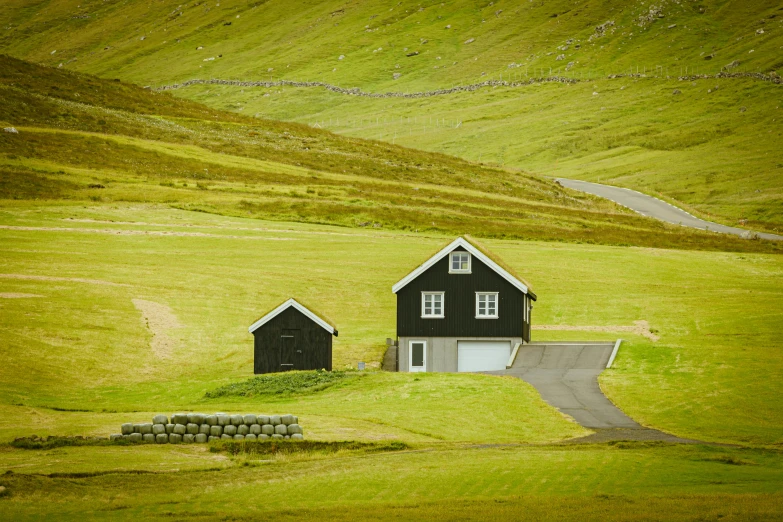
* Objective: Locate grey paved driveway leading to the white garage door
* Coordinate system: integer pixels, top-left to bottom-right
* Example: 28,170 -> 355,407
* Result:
486,343 -> 642,429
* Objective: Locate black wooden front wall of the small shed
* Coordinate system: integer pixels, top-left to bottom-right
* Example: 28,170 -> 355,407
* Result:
253,307 -> 332,373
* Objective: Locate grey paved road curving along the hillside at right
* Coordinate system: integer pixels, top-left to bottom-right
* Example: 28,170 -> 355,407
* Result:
557,178 -> 783,241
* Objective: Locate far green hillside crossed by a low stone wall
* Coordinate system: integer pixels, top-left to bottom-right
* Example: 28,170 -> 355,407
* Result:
0,0 -> 783,232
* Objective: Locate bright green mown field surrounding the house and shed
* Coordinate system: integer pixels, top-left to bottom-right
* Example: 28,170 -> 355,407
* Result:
0,202 -> 783,445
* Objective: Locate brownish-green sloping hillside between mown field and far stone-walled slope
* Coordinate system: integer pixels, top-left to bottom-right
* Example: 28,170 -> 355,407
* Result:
0,57 -> 781,251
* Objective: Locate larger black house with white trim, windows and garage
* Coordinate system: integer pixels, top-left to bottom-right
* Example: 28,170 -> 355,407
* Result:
392,237 -> 536,372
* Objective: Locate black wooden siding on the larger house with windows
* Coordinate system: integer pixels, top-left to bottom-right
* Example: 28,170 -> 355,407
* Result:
397,247 -> 525,337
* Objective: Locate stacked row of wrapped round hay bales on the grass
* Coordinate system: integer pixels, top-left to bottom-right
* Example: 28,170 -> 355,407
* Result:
110,413 -> 304,444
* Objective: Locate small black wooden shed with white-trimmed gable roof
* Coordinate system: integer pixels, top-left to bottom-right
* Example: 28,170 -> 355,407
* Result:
248,299 -> 337,373
